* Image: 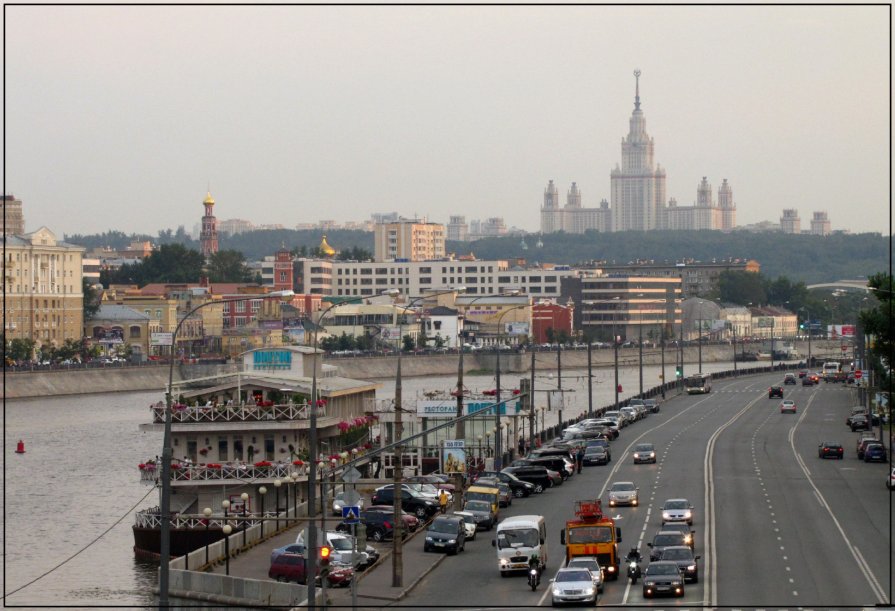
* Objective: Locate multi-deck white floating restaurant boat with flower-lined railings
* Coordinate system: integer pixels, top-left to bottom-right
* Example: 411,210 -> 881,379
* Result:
133,346 -> 379,558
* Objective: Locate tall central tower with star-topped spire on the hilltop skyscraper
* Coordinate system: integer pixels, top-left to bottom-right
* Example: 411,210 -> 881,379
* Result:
610,70 -> 665,231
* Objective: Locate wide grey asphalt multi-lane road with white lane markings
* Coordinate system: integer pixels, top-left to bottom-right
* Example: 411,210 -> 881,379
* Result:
401,374 -> 892,608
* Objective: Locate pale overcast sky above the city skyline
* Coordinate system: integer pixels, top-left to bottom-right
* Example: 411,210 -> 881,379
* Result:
4,6 -> 891,235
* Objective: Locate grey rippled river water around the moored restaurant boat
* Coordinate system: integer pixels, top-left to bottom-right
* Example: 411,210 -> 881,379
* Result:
2,353 -> 752,608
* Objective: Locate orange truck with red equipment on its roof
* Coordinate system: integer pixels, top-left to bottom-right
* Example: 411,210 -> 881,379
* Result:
560,499 -> 622,579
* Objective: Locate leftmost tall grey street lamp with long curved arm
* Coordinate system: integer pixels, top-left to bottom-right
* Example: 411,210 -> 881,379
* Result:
159,290 -> 295,607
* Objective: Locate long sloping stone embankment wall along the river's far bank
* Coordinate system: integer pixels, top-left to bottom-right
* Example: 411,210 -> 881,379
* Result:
3,341 -> 842,399
